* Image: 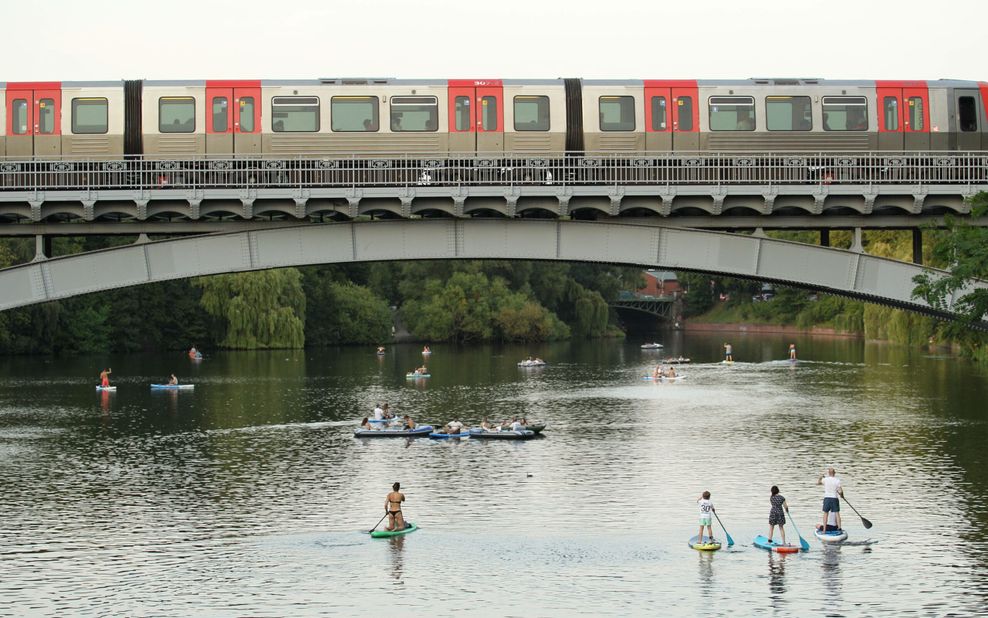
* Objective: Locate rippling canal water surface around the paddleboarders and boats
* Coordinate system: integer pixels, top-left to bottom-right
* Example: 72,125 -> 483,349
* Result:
0,333 -> 988,616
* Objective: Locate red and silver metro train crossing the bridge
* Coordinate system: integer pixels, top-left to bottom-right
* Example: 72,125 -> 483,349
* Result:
0,79 -> 988,160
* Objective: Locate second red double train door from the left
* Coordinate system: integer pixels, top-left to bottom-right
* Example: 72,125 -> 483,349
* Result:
206,82 -> 261,155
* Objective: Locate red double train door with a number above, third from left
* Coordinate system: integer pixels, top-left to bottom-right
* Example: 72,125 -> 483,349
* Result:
449,80 -> 504,154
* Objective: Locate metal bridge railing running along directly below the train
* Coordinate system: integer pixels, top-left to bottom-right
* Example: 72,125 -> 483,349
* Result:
0,152 -> 988,191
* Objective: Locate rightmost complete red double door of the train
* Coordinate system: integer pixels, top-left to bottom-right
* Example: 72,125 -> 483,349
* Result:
875,82 -> 930,151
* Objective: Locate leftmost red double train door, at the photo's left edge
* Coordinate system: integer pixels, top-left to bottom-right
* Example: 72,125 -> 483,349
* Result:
6,83 -> 62,157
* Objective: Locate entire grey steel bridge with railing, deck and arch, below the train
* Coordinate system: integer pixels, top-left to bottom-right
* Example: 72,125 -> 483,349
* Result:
0,152 -> 988,317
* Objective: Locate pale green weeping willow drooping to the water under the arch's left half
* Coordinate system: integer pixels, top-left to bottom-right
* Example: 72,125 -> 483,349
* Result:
195,268 -> 305,350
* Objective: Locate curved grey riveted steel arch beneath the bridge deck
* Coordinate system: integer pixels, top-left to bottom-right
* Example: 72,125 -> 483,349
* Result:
0,219 -> 988,328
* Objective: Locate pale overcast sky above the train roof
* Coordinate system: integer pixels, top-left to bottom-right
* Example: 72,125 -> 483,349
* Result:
0,0 -> 988,81
